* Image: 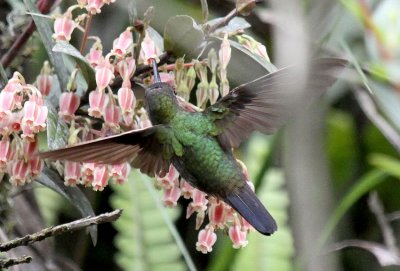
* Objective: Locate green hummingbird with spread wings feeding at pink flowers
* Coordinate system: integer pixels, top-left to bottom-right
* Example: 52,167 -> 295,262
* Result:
39,58 -> 347,235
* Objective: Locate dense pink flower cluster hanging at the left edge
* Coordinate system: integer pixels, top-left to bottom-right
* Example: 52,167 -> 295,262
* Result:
0,71 -> 47,185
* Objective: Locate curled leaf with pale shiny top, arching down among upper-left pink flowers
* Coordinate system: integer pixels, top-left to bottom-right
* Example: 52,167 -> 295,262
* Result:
53,41 -> 96,91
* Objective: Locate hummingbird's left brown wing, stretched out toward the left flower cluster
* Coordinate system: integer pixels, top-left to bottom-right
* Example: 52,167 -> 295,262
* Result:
39,125 -> 169,176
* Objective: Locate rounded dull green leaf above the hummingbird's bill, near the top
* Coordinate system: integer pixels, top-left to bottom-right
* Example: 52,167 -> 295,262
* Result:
164,15 -> 204,58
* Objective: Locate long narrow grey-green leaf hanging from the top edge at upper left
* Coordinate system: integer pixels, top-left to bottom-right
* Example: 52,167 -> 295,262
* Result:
24,0 -> 69,89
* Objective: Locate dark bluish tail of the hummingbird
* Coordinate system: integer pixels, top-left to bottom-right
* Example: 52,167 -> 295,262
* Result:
225,184 -> 277,235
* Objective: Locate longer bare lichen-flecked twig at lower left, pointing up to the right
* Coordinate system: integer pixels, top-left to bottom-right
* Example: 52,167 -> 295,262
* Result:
0,209 -> 122,252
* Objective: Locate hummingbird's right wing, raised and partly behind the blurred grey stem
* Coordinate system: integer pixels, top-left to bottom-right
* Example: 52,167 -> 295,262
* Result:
204,58 -> 347,149
